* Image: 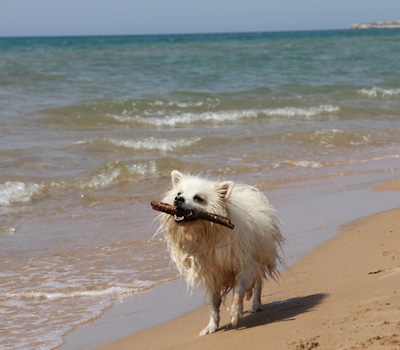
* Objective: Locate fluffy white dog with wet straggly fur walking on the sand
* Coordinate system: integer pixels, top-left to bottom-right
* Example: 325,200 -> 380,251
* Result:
159,170 -> 283,335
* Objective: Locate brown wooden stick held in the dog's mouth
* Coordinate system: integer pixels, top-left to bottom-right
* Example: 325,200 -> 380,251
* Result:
151,201 -> 235,229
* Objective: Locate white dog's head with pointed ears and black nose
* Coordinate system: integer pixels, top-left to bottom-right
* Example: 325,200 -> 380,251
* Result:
165,170 -> 234,222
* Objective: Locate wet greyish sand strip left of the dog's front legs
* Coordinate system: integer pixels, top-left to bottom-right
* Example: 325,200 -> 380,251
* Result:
60,279 -> 204,350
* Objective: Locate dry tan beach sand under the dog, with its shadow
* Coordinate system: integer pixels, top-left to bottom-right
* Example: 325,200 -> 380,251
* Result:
98,180 -> 400,350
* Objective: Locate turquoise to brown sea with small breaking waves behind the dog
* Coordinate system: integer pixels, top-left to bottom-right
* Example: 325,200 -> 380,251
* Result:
0,30 -> 400,349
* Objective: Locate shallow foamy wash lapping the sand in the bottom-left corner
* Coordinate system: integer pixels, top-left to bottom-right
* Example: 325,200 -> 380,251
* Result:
0,280 -> 156,349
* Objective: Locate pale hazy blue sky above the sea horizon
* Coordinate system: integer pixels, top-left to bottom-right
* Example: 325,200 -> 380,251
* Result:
0,0 -> 400,37
